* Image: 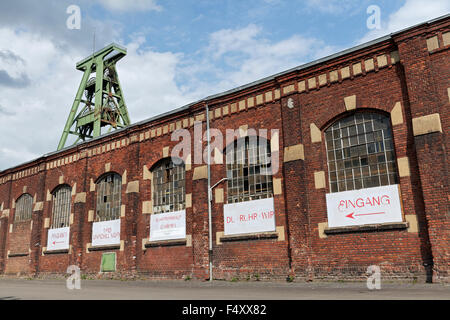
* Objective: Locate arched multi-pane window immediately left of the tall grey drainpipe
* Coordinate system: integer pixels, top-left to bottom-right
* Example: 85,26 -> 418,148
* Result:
152,158 -> 186,213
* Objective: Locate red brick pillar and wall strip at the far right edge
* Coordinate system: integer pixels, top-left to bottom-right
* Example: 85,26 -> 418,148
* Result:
397,23 -> 450,280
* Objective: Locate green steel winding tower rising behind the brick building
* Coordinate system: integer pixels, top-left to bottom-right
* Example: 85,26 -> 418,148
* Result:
58,43 -> 130,150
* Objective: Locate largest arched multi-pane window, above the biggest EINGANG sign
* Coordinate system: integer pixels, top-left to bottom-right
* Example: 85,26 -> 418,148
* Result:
325,112 -> 398,192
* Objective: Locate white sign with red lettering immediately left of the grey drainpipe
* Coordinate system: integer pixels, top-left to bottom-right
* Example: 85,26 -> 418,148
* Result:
150,210 -> 186,241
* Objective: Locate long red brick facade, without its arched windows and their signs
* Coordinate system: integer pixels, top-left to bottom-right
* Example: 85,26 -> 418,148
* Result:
0,16 -> 450,282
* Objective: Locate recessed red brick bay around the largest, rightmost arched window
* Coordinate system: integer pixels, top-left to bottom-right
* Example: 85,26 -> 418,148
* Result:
291,66 -> 429,277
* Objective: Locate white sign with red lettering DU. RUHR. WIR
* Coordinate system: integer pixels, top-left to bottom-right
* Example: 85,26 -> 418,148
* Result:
223,198 -> 275,235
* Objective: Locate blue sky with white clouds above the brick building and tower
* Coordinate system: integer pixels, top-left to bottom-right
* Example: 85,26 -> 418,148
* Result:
0,0 -> 450,170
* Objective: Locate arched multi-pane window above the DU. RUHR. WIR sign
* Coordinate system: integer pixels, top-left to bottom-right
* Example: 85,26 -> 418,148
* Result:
226,137 -> 273,203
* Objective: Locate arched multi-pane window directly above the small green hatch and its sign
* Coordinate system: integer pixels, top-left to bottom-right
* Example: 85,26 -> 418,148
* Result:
95,173 -> 122,222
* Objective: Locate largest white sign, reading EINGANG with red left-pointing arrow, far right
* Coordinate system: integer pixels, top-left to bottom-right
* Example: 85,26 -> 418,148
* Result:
326,184 -> 403,227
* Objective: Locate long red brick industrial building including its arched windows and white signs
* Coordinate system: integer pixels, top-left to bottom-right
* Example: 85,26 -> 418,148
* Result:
0,15 -> 450,282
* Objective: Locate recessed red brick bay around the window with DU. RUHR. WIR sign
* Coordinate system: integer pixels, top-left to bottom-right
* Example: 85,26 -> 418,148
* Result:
210,102 -> 289,279
